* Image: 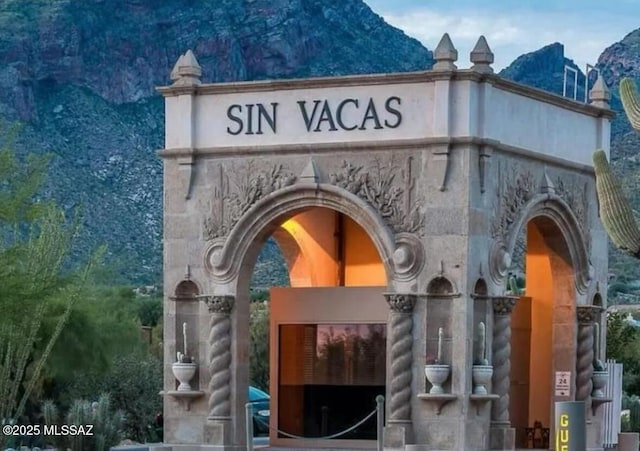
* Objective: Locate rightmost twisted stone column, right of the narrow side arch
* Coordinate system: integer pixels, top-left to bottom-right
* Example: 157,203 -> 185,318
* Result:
576,305 -> 600,404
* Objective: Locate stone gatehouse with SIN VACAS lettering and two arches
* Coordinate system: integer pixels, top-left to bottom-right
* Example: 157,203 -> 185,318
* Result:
160,36 -> 611,451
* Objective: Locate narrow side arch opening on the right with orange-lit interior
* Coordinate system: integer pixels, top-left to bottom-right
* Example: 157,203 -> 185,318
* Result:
506,208 -> 587,448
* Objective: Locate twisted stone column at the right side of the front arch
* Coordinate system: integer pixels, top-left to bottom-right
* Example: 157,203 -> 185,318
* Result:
385,293 -> 416,421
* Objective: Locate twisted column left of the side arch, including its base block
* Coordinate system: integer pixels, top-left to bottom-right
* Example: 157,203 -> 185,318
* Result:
490,296 -> 518,449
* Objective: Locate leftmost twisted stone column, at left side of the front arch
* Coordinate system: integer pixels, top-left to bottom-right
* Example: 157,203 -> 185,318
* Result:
205,296 -> 234,419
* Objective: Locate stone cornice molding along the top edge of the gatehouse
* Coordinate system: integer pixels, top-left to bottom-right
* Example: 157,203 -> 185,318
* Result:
156,70 -> 615,119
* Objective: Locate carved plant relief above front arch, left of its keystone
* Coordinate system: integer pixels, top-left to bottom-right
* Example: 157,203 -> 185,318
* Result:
203,160 -> 296,240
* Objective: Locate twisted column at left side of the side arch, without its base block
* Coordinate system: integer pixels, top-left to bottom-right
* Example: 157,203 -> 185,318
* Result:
491,296 -> 518,426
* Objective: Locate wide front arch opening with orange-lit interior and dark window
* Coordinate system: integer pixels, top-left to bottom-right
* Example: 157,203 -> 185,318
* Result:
222,186 -> 392,445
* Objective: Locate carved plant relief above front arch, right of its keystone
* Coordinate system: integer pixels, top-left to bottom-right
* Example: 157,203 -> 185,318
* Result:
329,156 -> 424,236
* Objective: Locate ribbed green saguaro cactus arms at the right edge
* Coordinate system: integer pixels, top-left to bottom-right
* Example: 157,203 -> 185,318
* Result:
593,78 -> 640,259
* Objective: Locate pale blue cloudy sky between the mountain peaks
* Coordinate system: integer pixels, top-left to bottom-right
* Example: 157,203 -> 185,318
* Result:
370,0 -> 638,71
